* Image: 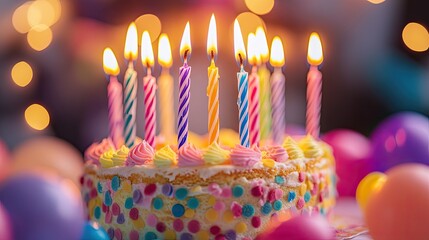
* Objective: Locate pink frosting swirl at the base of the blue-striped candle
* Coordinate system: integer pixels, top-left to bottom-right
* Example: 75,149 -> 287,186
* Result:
230,145 -> 261,167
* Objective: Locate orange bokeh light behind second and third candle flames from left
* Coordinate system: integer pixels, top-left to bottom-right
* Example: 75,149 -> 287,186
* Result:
135,14 -> 161,45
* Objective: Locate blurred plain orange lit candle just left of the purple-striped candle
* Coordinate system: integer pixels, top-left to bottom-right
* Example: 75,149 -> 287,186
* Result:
158,33 -> 175,140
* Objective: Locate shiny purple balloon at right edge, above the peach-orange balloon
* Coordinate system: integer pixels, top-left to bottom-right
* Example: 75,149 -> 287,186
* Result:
371,112 -> 429,172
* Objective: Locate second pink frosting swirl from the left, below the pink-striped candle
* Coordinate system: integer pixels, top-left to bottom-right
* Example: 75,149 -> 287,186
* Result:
125,140 -> 155,166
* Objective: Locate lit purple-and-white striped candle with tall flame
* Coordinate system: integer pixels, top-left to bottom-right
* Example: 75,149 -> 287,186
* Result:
177,22 -> 192,148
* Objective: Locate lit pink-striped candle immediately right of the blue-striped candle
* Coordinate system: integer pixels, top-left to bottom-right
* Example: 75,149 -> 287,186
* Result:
247,33 -> 261,146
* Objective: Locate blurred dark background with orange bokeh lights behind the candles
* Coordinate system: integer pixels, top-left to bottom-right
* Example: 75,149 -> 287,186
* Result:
0,0 -> 429,151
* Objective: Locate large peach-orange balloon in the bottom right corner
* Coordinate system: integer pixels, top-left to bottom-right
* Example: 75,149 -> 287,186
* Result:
365,164 -> 429,240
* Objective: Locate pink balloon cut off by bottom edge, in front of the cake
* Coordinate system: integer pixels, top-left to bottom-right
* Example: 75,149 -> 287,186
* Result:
257,215 -> 335,240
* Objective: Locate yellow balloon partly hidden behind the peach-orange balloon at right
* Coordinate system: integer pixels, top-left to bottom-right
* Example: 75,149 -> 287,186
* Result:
356,172 -> 386,211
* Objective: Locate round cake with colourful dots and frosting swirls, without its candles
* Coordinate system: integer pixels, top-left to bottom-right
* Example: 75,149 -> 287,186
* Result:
82,136 -> 336,239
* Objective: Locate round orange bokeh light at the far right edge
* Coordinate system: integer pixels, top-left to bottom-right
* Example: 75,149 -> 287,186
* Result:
402,22 -> 429,52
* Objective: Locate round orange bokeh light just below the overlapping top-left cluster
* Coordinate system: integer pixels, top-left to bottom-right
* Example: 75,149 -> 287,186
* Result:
27,25 -> 52,51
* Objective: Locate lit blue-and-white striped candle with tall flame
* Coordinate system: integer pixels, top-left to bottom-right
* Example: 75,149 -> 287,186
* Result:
234,19 -> 250,147
